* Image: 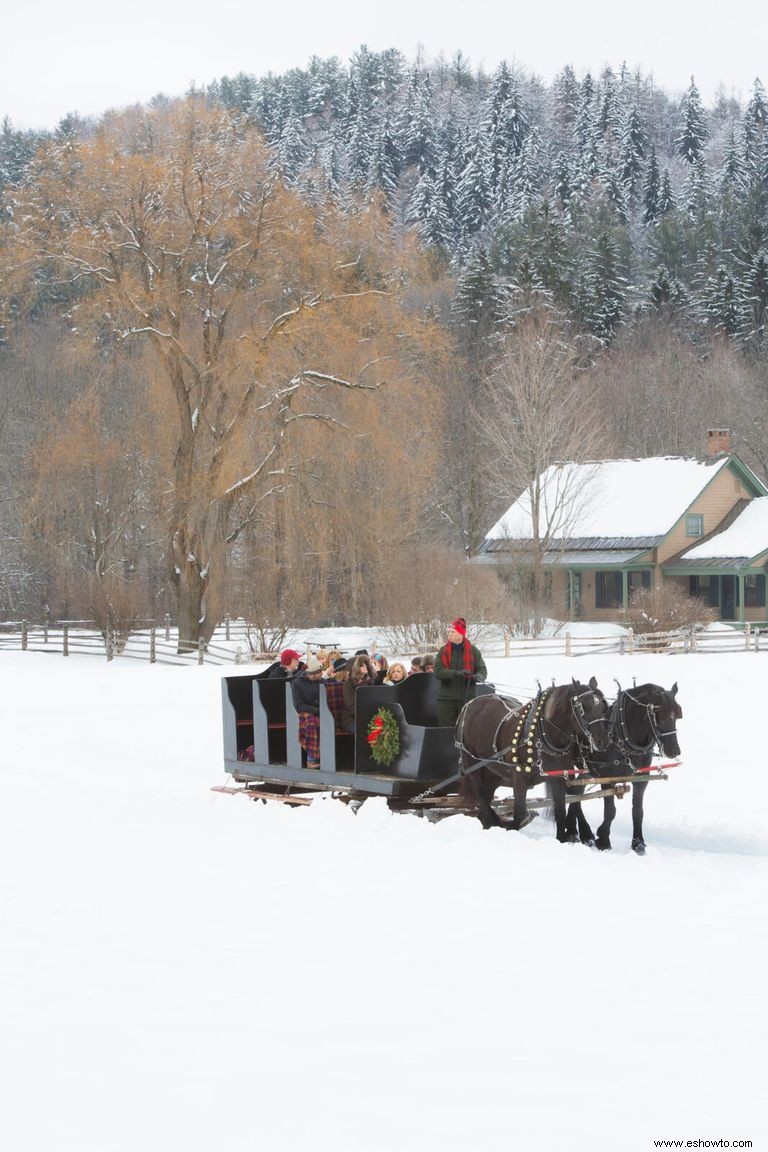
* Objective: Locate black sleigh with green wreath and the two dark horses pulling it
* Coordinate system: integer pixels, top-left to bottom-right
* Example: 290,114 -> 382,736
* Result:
215,674 -> 682,854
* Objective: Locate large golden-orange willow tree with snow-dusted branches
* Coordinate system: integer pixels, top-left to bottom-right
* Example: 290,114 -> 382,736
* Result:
1,99 -> 444,647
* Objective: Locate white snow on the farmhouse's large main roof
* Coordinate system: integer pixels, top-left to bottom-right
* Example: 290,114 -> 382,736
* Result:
488,456 -> 728,540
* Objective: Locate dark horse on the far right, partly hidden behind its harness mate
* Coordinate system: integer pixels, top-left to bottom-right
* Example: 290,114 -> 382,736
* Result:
567,683 -> 683,856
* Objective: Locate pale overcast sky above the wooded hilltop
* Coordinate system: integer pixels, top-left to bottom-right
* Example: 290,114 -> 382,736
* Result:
6,0 -> 768,128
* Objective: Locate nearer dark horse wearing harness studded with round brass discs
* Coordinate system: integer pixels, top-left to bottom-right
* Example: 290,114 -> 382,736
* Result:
456,676 -> 609,841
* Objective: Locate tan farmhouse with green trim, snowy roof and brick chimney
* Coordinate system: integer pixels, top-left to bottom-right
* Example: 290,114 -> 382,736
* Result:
476,430 -> 768,621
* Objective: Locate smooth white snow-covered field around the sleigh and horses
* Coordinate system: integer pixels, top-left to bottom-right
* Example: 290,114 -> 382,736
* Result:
0,653 -> 768,1152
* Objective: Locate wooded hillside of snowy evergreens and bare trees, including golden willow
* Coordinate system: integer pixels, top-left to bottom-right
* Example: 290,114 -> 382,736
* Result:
0,47 -> 768,639
